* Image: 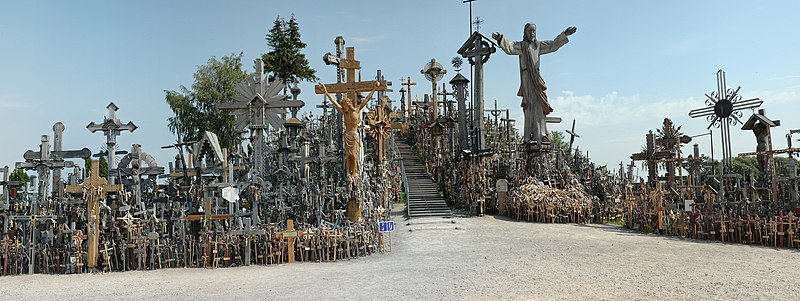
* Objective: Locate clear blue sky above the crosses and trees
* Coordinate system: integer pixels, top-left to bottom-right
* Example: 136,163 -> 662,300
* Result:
0,0 -> 800,176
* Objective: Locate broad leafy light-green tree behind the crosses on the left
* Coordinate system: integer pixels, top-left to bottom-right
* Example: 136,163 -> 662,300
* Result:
164,53 -> 248,149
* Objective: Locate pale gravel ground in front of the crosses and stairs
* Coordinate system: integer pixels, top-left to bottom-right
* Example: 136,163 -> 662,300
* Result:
0,205 -> 800,300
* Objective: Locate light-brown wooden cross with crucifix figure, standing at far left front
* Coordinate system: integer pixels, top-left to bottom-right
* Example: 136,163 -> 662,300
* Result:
67,160 -> 123,270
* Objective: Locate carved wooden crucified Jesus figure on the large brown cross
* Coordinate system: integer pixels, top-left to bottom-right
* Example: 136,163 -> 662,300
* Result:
319,83 -> 380,183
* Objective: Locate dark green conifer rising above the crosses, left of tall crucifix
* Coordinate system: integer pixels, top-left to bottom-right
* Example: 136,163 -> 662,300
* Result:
261,16 -> 319,84
